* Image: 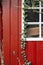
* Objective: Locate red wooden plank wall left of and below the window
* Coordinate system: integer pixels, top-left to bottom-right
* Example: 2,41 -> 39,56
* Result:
2,0 -> 43,65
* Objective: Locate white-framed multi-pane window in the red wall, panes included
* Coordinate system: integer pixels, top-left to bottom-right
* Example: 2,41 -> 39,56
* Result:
22,0 -> 43,41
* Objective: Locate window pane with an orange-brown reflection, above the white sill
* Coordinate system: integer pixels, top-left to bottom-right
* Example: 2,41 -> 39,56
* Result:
26,25 -> 39,37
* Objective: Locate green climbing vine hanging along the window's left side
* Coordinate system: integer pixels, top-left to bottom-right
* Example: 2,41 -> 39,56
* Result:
21,0 -> 31,65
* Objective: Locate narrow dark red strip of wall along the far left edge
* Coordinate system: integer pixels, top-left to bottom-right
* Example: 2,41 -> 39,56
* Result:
0,4 -> 3,65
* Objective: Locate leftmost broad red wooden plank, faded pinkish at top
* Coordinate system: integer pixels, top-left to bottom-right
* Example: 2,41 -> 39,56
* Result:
2,0 -> 11,65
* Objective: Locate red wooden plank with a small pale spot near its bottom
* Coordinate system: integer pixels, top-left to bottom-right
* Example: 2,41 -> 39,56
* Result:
11,0 -> 19,65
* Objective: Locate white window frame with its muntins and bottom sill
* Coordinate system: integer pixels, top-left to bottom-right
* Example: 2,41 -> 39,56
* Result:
22,0 -> 43,41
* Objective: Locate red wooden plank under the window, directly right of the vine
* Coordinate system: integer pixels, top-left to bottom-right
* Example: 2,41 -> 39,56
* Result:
26,41 -> 37,65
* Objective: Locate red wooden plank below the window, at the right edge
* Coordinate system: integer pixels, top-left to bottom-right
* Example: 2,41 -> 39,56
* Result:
36,41 -> 43,65
